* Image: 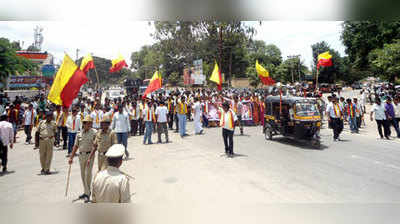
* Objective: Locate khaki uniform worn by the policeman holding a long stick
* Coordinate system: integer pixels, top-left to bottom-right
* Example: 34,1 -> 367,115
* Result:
75,122 -> 96,195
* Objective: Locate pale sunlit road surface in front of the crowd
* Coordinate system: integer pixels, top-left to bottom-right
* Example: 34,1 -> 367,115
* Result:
0,89 -> 400,205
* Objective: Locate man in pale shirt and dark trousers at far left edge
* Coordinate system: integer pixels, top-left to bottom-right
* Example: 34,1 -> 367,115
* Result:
0,114 -> 14,173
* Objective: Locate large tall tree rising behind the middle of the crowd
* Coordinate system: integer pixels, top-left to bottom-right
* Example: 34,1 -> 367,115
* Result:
153,21 -> 255,84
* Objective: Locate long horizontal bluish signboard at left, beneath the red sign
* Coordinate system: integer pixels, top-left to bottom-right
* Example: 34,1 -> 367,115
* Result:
8,76 -> 52,89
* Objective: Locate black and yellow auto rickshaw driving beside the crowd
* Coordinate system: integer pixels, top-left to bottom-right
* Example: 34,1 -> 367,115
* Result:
263,96 -> 321,148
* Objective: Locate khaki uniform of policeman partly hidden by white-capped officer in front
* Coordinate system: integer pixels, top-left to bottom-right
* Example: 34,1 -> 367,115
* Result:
94,129 -> 117,171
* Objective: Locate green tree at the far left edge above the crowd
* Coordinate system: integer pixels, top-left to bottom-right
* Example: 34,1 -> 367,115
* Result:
0,38 -> 37,79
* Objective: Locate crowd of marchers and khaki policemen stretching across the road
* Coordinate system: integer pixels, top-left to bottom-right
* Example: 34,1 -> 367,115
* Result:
0,84 -> 400,201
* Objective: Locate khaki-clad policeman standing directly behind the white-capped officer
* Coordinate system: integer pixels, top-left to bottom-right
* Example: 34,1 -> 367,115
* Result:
87,116 -> 117,171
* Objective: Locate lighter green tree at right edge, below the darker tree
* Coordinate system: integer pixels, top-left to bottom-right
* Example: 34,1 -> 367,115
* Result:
368,40 -> 400,82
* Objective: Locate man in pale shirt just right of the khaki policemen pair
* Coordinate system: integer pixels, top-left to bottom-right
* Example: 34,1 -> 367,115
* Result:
111,104 -> 131,158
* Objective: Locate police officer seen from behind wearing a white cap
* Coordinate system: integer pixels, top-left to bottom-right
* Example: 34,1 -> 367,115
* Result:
92,144 -> 131,203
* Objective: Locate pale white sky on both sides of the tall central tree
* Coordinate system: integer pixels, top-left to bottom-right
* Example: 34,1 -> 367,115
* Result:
0,21 -> 345,70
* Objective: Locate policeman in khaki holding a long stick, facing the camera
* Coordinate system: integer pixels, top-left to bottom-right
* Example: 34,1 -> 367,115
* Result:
68,115 -> 96,203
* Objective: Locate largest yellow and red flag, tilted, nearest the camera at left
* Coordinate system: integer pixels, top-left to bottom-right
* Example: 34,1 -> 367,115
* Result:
47,54 -> 88,107
